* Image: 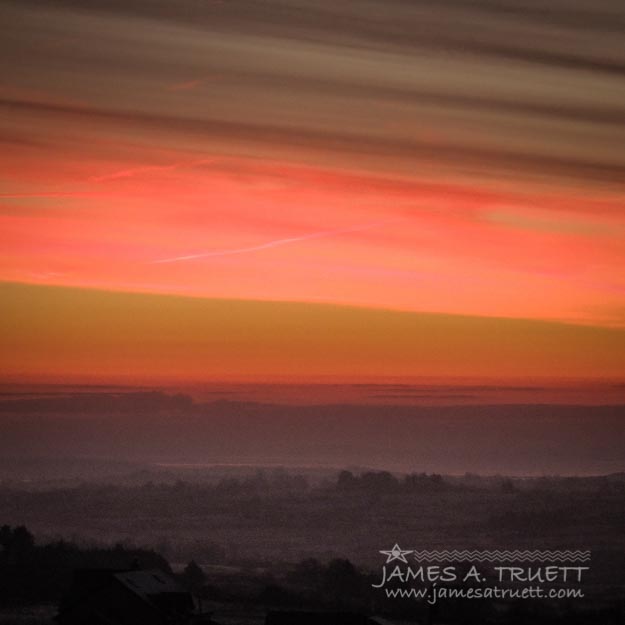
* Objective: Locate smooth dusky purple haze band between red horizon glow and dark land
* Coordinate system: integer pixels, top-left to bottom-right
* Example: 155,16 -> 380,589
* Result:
0,386 -> 625,475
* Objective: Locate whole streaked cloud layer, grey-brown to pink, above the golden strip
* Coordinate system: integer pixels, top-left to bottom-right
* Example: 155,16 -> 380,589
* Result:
0,0 -> 625,326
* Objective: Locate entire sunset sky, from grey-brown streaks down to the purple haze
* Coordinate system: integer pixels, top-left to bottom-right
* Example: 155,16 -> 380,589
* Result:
0,0 -> 625,383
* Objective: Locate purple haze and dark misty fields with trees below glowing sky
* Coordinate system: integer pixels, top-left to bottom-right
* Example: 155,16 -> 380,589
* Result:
0,383 -> 625,625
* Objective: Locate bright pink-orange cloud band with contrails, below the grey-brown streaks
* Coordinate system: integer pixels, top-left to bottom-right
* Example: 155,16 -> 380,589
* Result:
0,153 -> 625,326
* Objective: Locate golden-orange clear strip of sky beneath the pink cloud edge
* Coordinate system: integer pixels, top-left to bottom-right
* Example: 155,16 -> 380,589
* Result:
0,283 -> 625,385
